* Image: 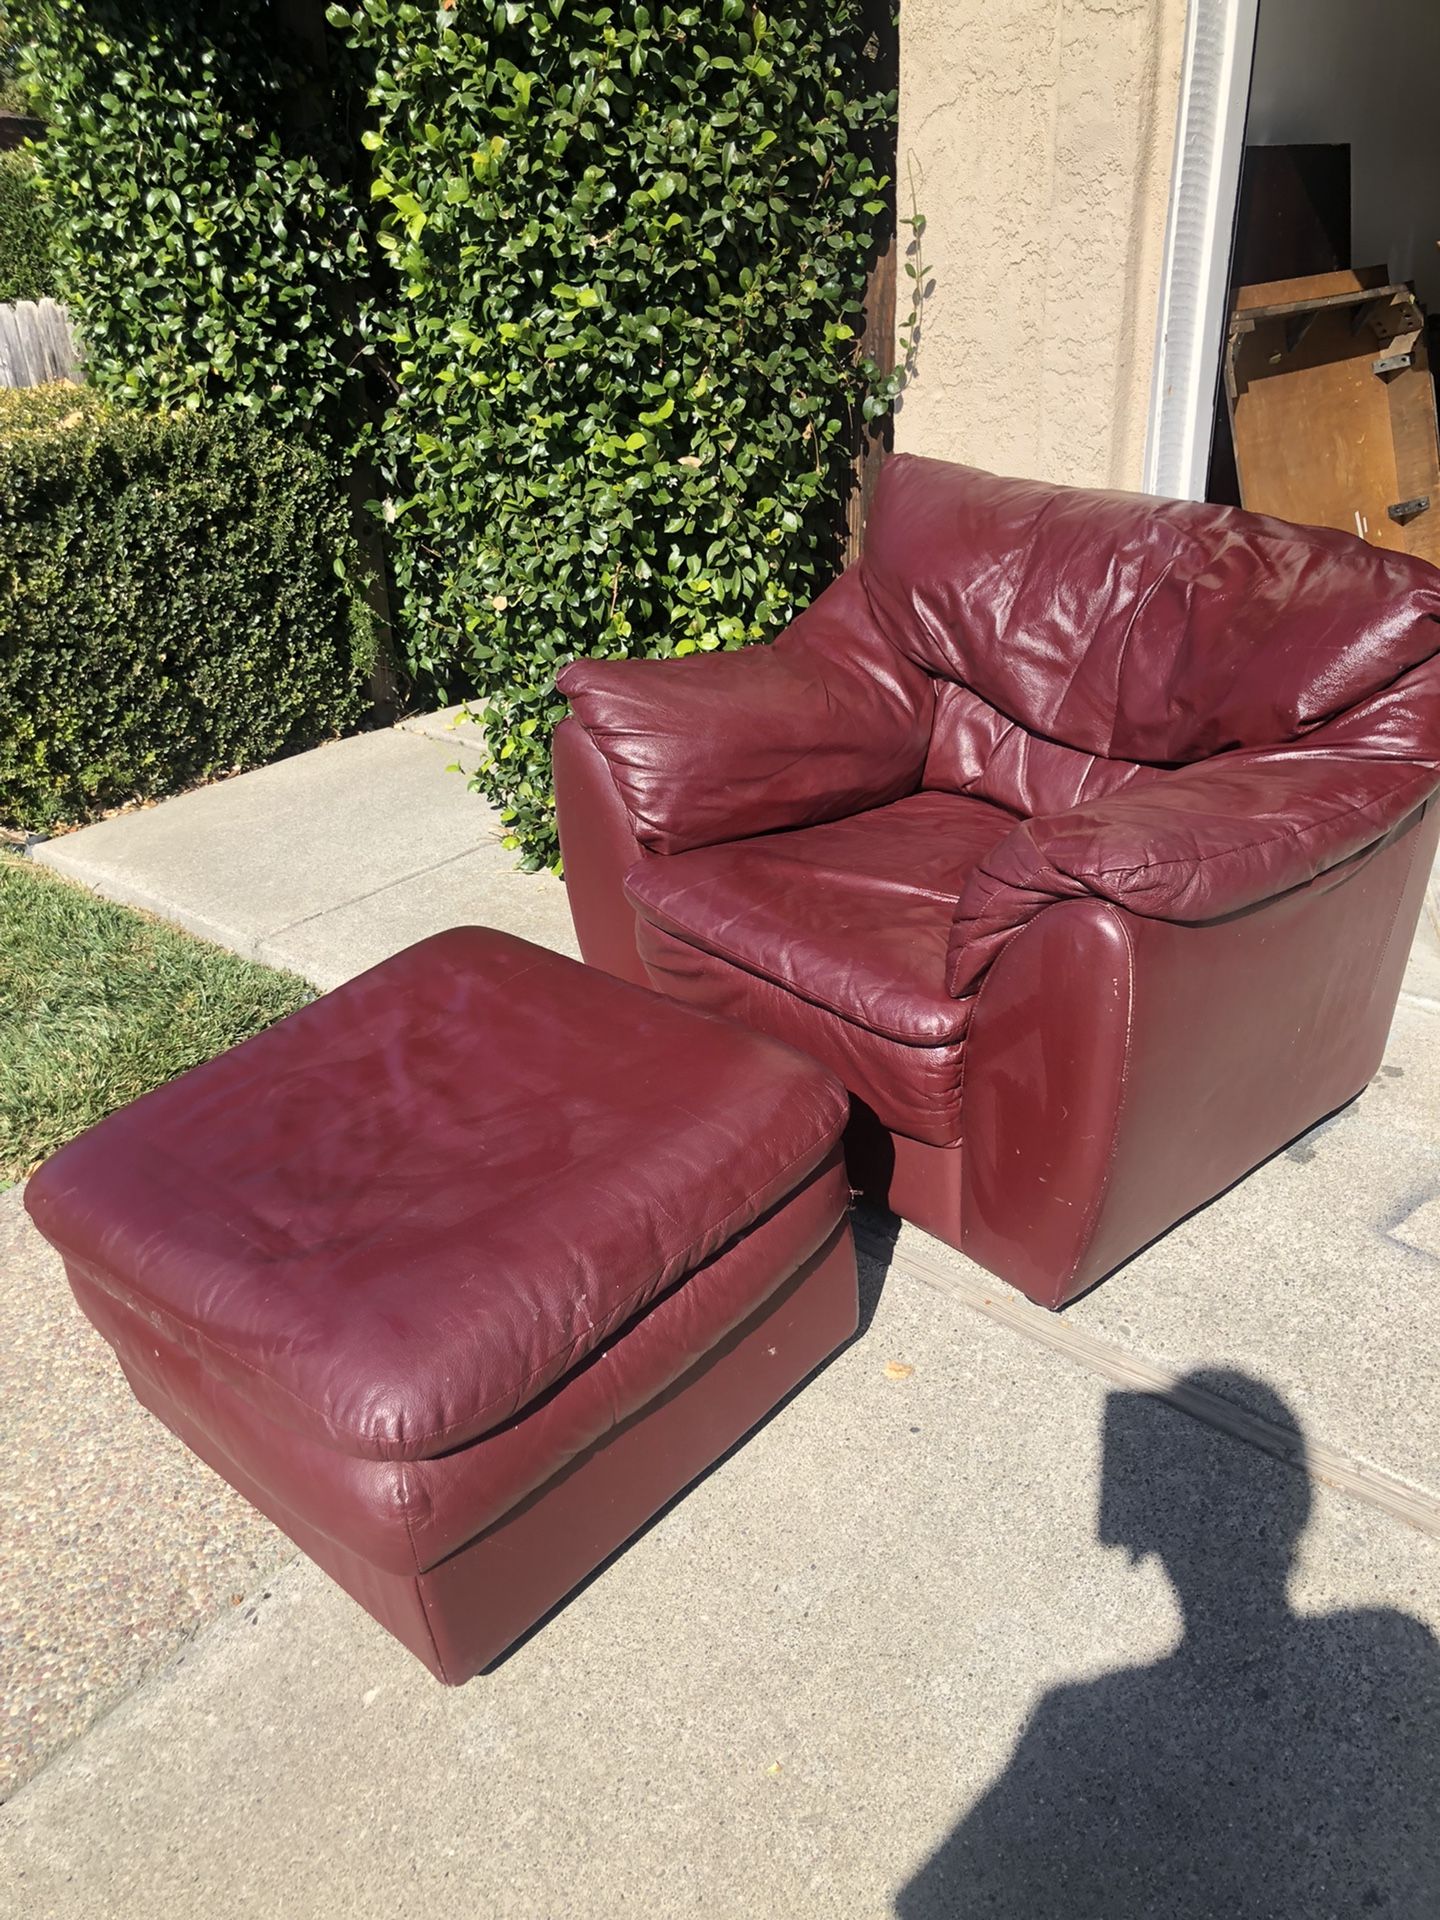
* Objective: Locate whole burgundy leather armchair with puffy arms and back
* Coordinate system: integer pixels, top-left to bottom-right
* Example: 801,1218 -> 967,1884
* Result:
555,457 -> 1440,1308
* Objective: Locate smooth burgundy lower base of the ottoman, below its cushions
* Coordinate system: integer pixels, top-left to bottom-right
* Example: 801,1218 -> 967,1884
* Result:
119,1219 -> 856,1686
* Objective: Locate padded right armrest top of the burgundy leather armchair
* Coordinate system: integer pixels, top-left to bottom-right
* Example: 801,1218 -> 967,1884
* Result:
948,745 -> 1440,995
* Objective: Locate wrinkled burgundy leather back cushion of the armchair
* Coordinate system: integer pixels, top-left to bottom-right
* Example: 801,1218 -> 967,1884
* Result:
862,455 -> 1440,764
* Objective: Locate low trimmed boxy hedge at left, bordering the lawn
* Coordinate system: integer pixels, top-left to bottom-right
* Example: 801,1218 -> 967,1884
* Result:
0,386 -> 369,829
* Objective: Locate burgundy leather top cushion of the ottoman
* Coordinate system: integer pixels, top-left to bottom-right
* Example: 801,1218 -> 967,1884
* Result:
27,927 -> 847,1459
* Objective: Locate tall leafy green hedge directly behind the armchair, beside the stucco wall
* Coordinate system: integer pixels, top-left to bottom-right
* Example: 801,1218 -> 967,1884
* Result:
328,0 -> 897,866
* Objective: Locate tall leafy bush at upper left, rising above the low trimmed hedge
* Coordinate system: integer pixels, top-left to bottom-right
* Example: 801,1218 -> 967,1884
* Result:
8,0 -> 369,447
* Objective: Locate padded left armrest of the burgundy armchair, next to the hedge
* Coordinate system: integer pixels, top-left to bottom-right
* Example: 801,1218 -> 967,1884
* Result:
557,568 -> 935,852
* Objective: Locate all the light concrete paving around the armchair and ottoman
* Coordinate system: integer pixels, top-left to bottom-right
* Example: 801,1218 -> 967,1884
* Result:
0,733 -> 1440,1920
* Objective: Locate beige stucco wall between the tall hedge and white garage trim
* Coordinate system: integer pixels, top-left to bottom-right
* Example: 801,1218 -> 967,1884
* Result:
895,0 -> 1185,488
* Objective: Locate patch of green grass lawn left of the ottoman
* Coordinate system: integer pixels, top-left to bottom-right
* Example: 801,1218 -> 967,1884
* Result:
0,852 -> 313,1187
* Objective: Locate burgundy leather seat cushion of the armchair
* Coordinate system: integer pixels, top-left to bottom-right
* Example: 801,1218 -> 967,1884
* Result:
626,793 -> 1016,1046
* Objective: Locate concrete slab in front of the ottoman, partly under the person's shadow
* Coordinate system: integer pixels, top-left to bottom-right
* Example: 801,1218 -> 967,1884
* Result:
0,1236 -> 1440,1920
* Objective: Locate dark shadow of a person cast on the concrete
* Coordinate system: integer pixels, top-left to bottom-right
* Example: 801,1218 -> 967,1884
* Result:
897,1373 -> 1440,1920
